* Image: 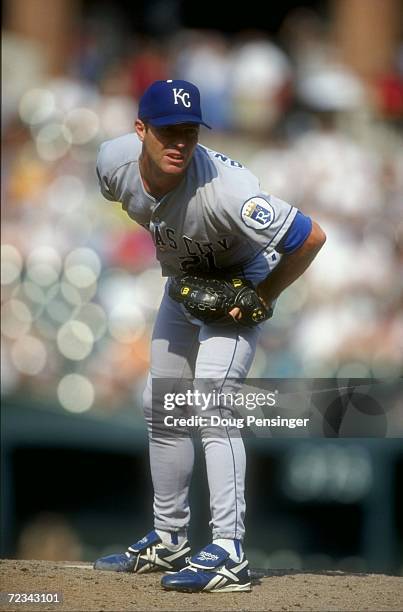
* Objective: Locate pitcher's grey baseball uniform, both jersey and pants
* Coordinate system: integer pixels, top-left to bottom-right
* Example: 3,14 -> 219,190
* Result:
97,133 -> 298,540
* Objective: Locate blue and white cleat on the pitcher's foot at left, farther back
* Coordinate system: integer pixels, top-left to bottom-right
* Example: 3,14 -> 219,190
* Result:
94,531 -> 190,574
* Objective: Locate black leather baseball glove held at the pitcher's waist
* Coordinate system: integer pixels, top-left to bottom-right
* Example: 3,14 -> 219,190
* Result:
169,275 -> 273,327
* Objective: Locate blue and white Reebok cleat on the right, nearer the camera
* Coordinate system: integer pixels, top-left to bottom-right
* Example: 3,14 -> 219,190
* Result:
161,544 -> 251,593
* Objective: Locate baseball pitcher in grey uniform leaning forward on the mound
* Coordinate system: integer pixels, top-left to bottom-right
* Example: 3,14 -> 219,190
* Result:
94,80 -> 325,592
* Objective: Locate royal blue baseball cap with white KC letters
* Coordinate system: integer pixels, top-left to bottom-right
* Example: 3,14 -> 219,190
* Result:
138,79 -> 211,129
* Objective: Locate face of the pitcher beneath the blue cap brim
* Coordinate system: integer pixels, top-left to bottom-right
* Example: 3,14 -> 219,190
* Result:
136,120 -> 199,175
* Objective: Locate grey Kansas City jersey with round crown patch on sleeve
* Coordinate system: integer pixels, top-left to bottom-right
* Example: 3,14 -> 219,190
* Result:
97,133 -> 297,282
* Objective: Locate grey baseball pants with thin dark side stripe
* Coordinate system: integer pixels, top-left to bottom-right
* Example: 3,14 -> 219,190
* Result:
143,283 -> 260,540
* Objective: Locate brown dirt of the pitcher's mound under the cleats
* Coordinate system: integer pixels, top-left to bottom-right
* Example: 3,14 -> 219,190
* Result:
0,560 -> 403,612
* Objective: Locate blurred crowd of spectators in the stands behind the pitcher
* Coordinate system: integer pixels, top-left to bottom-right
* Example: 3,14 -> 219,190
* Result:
1,0 -> 403,572
